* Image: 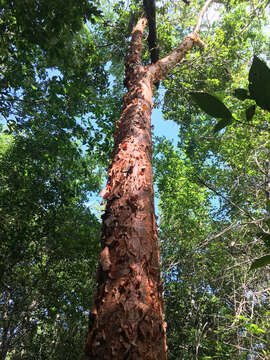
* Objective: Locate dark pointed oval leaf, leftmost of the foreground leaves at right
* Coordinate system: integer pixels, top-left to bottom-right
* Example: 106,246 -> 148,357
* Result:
190,92 -> 232,119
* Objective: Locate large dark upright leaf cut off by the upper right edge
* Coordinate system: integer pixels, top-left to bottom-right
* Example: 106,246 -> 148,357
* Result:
248,56 -> 270,111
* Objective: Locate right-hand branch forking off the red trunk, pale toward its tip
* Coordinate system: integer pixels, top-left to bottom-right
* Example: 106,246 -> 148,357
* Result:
149,0 -> 214,83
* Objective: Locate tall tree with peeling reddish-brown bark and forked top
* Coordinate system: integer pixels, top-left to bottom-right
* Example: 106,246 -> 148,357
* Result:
84,0 -> 213,360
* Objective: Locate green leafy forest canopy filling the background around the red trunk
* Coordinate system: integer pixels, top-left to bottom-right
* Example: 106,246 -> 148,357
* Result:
0,0 -> 270,360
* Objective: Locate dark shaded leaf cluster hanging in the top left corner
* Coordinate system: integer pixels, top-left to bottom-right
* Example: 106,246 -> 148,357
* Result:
0,0 -> 101,56
